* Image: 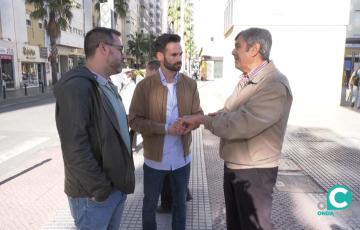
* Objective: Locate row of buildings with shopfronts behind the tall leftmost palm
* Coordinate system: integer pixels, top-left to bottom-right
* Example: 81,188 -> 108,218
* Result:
0,0 -> 92,90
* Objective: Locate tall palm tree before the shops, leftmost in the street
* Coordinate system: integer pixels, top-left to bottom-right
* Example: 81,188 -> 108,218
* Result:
25,0 -> 74,84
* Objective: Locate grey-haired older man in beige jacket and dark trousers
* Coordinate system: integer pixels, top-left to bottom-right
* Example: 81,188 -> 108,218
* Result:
182,28 -> 292,230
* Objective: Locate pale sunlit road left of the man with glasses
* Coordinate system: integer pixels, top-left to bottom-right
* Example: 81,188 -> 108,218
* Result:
0,100 -> 59,176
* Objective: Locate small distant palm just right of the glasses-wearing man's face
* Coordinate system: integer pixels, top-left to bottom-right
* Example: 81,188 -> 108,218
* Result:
127,33 -> 149,68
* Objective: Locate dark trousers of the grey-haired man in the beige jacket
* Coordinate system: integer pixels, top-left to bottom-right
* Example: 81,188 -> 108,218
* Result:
224,166 -> 278,230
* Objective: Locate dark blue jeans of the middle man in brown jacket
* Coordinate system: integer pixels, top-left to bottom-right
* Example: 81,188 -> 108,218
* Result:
142,164 -> 190,230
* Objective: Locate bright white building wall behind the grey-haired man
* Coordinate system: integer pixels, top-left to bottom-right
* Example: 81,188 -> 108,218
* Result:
224,0 -> 350,126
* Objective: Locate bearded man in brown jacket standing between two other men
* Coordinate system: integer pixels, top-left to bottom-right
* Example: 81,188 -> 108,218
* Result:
129,34 -> 202,230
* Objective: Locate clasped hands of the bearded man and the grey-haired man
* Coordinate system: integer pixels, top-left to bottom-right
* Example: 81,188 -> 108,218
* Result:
167,114 -> 204,136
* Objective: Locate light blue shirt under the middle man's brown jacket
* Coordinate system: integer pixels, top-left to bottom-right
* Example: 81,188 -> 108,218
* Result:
145,69 -> 191,170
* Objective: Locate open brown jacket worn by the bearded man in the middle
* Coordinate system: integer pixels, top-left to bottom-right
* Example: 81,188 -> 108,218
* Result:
129,72 -> 202,161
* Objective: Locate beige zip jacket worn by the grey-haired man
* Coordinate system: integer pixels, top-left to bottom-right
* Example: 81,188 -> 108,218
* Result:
205,62 -> 292,169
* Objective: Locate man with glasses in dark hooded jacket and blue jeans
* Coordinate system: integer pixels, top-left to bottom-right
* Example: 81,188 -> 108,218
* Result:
54,27 -> 135,229
